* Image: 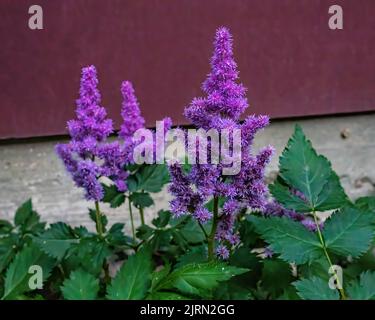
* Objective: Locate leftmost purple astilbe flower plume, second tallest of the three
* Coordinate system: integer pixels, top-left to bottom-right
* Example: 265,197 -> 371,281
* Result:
56,66 -> 127,201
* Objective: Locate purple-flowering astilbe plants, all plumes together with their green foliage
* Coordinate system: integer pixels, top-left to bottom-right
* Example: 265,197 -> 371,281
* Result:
0,28 -> 375,300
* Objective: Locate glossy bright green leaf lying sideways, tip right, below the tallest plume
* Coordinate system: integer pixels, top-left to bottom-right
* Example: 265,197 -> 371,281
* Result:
158,262 -> 248,297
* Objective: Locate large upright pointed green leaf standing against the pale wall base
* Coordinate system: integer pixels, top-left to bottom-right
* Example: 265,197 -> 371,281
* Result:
270,125 -> 348,212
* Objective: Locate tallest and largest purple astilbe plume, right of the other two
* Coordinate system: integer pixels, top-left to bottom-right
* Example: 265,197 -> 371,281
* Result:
169,28 -> 274,258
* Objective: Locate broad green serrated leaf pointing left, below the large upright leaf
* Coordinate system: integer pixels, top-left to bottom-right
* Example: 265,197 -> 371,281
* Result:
248,216 -> 323,264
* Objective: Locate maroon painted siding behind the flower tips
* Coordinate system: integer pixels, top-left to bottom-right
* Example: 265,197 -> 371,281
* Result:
0,0 -> 375,138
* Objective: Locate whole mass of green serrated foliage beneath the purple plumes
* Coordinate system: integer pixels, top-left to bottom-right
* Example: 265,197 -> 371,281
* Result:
0,122 -> 375,300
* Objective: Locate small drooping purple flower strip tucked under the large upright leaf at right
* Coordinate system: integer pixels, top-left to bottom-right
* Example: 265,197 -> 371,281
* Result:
263,200 -> 324,232
